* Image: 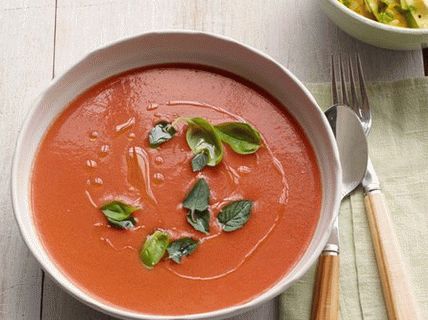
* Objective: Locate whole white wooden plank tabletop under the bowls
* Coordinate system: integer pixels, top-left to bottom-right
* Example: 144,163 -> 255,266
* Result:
0,0 -> 428,320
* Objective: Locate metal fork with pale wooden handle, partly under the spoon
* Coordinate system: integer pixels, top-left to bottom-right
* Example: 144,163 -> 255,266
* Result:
332,54 -> 420,320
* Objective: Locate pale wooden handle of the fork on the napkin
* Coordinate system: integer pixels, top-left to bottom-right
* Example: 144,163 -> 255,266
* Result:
364,190 -> 420,320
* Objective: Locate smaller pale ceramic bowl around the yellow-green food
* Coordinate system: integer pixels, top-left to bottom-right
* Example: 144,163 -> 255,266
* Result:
320,0 -> 428,50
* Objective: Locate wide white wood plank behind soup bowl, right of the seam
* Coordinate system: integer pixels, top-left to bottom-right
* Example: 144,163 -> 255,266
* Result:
43,0 -> 423,320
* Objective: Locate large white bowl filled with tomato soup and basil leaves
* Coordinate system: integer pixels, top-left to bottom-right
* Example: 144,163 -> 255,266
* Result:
12,32 -> 340,319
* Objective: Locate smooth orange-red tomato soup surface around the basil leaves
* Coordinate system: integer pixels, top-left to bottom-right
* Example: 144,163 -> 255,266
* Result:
32,65 -> 321,315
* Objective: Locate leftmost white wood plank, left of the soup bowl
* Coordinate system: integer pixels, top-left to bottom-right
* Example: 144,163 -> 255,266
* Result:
0,0 -> 55,320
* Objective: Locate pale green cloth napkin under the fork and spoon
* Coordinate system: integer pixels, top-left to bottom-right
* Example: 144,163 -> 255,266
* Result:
280,78 -> 428,320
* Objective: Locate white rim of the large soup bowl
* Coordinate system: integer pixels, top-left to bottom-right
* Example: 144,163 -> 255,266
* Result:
10,29 -> 343,320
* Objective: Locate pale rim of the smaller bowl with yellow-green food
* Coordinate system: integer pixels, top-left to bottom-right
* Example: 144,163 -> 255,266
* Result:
327,0 -> 428,35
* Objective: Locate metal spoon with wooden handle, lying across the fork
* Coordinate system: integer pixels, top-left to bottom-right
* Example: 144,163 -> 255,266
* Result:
312,105 -> 368,320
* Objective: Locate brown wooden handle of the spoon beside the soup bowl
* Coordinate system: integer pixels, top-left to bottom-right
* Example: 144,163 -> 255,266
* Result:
311,253 -> 339,320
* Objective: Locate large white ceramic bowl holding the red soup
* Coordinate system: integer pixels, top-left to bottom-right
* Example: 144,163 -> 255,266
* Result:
12,31 -> 341,319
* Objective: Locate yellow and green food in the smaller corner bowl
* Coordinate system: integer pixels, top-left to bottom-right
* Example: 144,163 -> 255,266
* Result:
338,0 -> 428,28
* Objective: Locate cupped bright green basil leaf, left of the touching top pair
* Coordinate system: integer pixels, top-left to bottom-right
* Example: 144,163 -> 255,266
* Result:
186,118 -> 223,167
